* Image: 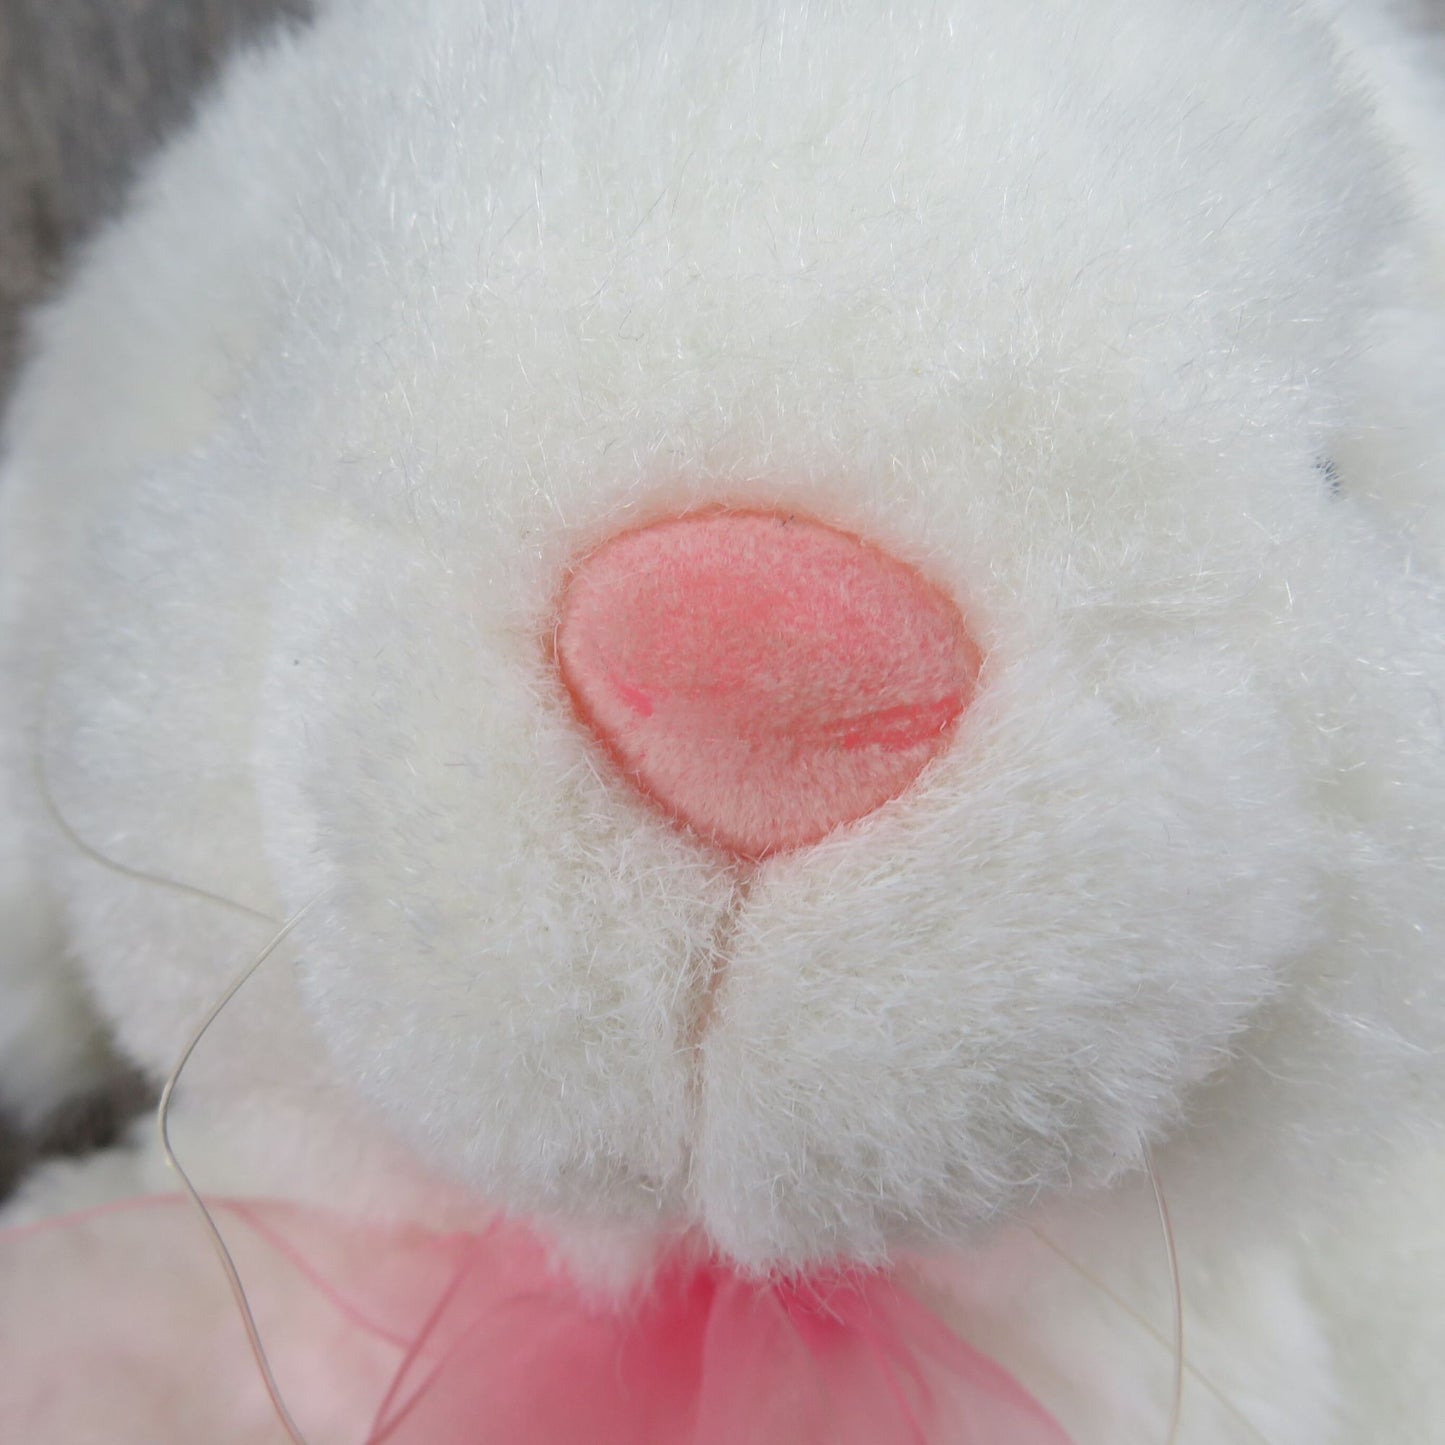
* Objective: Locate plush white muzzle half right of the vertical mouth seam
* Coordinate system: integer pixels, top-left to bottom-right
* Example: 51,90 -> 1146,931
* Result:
692,644 -> 1318,1263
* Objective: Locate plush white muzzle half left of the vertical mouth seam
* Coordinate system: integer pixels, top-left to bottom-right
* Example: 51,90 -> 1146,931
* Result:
252,522 -> 731,1218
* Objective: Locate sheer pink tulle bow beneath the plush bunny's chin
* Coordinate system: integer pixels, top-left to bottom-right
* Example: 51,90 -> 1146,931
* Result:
0,1199 -> 1068,1445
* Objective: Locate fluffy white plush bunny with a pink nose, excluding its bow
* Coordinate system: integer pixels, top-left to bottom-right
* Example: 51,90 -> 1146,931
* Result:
0,0 -> 1445,1445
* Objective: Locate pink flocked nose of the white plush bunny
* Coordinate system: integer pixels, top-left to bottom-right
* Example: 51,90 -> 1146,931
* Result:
556,512 -> 980,858
